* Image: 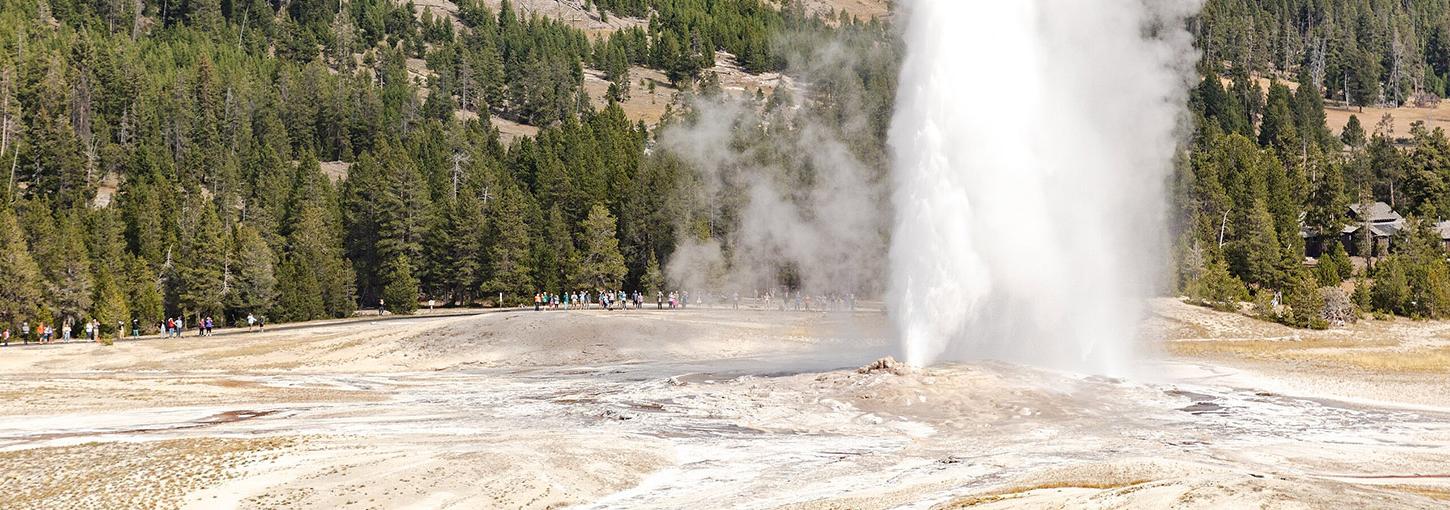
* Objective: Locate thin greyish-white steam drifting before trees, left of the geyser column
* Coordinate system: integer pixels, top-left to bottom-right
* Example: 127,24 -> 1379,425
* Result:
658,49 -> 890,297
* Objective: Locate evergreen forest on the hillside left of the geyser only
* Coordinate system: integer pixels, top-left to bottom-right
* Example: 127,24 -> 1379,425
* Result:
0,0 -> 895,332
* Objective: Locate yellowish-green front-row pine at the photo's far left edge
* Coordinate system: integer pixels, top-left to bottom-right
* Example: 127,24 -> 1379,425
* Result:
0,209 -> 42,330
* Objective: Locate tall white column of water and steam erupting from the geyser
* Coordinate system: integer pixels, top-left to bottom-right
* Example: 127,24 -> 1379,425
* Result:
890,0 -> 1198,372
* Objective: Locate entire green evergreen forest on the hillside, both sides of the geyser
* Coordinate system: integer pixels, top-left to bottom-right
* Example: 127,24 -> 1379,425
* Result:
8,0 -> 1450,332
